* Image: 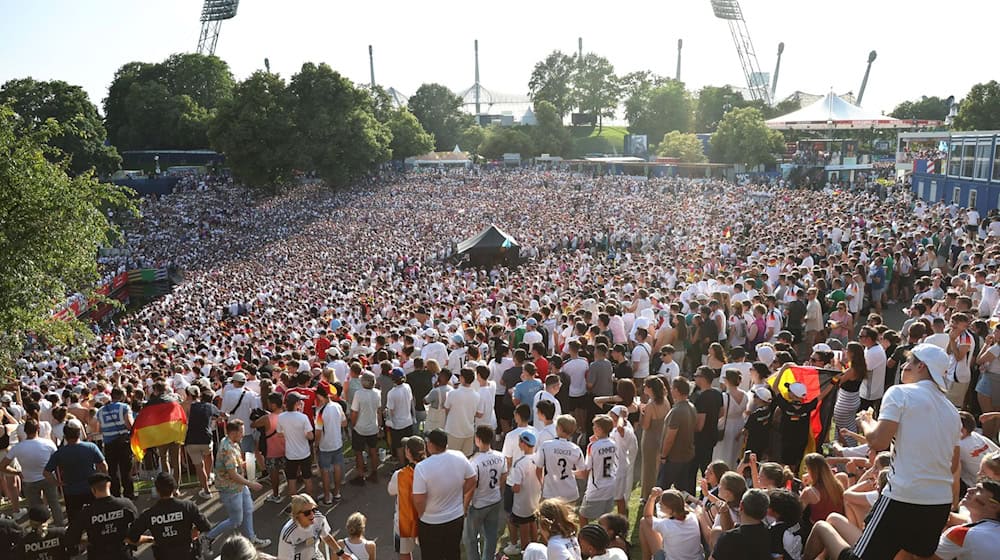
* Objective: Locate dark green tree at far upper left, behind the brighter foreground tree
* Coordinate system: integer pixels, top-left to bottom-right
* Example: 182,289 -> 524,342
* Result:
0,78 -> 121,175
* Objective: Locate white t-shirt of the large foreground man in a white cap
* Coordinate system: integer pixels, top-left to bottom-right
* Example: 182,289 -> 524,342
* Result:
879,380 -> 962,505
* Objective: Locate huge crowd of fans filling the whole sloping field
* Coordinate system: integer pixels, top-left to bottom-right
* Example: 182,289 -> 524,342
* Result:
0,169 -> 1000,560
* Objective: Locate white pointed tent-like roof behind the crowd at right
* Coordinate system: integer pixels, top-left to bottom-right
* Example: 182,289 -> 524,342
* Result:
767,92 -> 936,130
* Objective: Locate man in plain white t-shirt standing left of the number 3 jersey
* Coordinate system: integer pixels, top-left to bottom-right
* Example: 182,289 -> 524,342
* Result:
413,428 -> 478,560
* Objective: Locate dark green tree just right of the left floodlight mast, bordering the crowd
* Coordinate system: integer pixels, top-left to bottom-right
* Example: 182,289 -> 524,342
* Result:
208,71 -> 296,192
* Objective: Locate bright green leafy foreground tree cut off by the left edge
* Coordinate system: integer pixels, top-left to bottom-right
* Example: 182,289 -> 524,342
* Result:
0,107 -> 134,365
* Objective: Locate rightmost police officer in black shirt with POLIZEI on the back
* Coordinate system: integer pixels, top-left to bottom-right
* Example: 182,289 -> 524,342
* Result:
128,472 -> 212,560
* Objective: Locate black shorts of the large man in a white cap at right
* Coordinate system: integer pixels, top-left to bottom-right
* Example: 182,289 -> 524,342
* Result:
841,496 -> 951,560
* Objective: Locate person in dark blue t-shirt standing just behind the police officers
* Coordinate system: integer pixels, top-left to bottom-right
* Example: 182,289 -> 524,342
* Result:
44,422 -> 108,519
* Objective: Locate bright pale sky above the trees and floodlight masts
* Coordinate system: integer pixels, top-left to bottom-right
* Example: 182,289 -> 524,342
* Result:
0,0 -> 1000,117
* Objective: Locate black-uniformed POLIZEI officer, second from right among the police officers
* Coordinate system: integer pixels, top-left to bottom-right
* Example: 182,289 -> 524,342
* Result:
66,472 -> 141,560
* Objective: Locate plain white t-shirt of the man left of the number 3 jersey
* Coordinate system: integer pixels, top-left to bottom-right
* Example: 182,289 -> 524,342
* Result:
413,451 -> 476,525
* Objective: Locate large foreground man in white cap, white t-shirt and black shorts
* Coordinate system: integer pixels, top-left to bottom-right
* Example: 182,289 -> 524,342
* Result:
852,344 -> 961,560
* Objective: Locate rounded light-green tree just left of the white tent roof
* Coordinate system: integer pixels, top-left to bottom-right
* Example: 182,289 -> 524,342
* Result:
712,107 -> 784,167
